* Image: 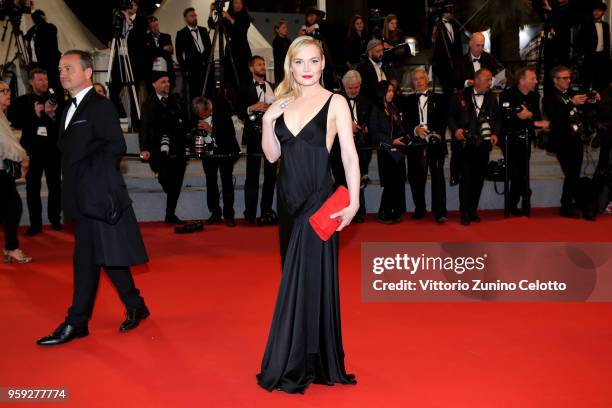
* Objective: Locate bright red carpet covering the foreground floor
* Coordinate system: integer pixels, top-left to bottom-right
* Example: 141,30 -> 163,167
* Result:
0,210 -> 612,408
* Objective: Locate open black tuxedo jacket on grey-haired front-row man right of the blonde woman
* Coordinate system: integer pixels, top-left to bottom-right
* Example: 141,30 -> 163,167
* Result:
400,92 -> 448,157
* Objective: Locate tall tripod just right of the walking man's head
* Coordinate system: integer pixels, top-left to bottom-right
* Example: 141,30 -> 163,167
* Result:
106,22 -> 140,129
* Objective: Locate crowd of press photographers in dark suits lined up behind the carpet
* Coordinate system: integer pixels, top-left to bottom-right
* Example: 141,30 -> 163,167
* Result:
0,0 -> 612,263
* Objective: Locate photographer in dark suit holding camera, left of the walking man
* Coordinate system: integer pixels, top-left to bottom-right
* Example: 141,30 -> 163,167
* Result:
9,68 -> 62,237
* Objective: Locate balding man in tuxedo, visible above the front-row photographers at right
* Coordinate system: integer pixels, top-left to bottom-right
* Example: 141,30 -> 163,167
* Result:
455,33 -> 497,89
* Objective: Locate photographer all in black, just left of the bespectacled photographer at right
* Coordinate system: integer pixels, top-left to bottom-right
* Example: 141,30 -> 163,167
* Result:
499,68 -> 549,217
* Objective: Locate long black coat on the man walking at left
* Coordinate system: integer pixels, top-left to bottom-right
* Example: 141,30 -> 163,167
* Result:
58,88 -> 147,266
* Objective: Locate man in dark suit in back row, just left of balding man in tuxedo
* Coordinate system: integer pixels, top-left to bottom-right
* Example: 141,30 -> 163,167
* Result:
432,13 -> 463,94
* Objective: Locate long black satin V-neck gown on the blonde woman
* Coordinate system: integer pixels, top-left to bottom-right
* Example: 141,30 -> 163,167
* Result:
257,95 -> 356,393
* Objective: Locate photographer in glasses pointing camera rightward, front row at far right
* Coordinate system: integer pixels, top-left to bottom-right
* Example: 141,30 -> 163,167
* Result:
542,66 -> 599,221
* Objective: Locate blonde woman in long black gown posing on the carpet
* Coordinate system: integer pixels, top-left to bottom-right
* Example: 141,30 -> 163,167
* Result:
257,36 -> 359,393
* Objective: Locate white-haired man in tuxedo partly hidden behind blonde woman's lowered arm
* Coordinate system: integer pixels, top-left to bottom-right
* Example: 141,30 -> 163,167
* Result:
338,70 -> 373,224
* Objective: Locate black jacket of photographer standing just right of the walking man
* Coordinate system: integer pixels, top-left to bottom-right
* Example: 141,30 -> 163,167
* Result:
140,93 -> 187,157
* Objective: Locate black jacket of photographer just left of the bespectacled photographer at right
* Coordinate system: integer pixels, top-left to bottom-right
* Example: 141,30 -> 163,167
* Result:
499,86 -> 542,143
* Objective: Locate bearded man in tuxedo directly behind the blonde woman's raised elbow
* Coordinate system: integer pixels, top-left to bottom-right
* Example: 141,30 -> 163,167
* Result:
236,55 -> 278,225
